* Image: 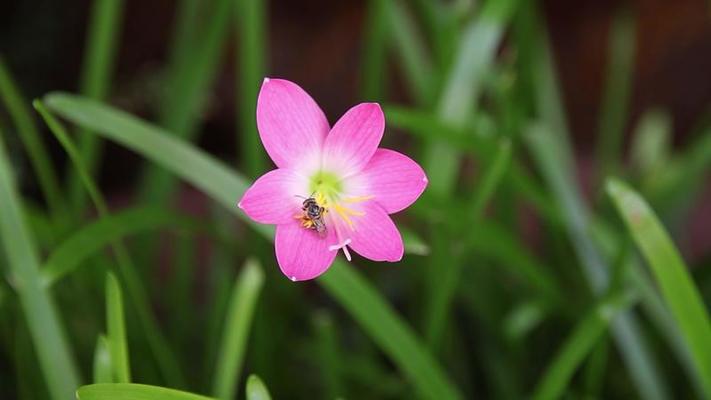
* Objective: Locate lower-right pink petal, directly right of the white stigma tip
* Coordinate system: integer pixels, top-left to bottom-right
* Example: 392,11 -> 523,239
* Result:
349,201 -> 404,262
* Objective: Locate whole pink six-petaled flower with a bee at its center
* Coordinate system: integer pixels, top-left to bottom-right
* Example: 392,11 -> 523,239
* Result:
238,78 -> 427,281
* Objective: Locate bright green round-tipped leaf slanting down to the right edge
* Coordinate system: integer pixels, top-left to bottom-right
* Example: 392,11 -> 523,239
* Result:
607,179 -> 711,398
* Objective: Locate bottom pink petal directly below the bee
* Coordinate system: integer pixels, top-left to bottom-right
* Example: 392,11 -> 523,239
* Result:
274,220 -> 337,281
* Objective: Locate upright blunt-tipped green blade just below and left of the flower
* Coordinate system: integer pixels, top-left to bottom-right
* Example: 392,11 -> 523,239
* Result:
212,260 -> 264,400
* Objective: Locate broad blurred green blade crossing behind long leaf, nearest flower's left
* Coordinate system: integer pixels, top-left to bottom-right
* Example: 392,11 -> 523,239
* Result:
140,0 -> 234,203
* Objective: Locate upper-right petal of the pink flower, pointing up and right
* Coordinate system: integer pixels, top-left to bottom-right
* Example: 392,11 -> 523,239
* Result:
323,103 -> 385,176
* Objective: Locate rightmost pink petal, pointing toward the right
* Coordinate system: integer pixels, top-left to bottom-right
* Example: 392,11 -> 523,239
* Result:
356,149 -> 427,214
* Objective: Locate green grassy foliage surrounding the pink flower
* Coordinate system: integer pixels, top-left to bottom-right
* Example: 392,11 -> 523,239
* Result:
0,0 -> 711,400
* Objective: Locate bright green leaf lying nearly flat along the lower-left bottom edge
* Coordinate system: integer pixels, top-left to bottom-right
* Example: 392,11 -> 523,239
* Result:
76,383 -> 214,400
